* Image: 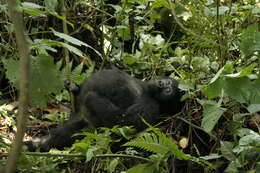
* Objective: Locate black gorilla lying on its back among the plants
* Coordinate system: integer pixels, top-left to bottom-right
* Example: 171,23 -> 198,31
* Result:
26,68 -> 182,151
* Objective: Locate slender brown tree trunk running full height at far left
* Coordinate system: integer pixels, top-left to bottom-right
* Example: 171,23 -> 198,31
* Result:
5,0 -> 30,173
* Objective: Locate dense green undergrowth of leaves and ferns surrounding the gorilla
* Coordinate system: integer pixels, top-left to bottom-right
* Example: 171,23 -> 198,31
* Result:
0,0 -> 260,173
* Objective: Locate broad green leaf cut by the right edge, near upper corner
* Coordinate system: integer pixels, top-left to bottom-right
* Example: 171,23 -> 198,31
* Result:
240,24 -> 260,56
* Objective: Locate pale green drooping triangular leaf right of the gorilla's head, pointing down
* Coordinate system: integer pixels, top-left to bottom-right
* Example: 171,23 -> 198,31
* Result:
201,103 -> 226,133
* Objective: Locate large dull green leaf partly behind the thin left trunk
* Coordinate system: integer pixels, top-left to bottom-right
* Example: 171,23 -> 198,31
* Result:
3,55 -> 63,107
